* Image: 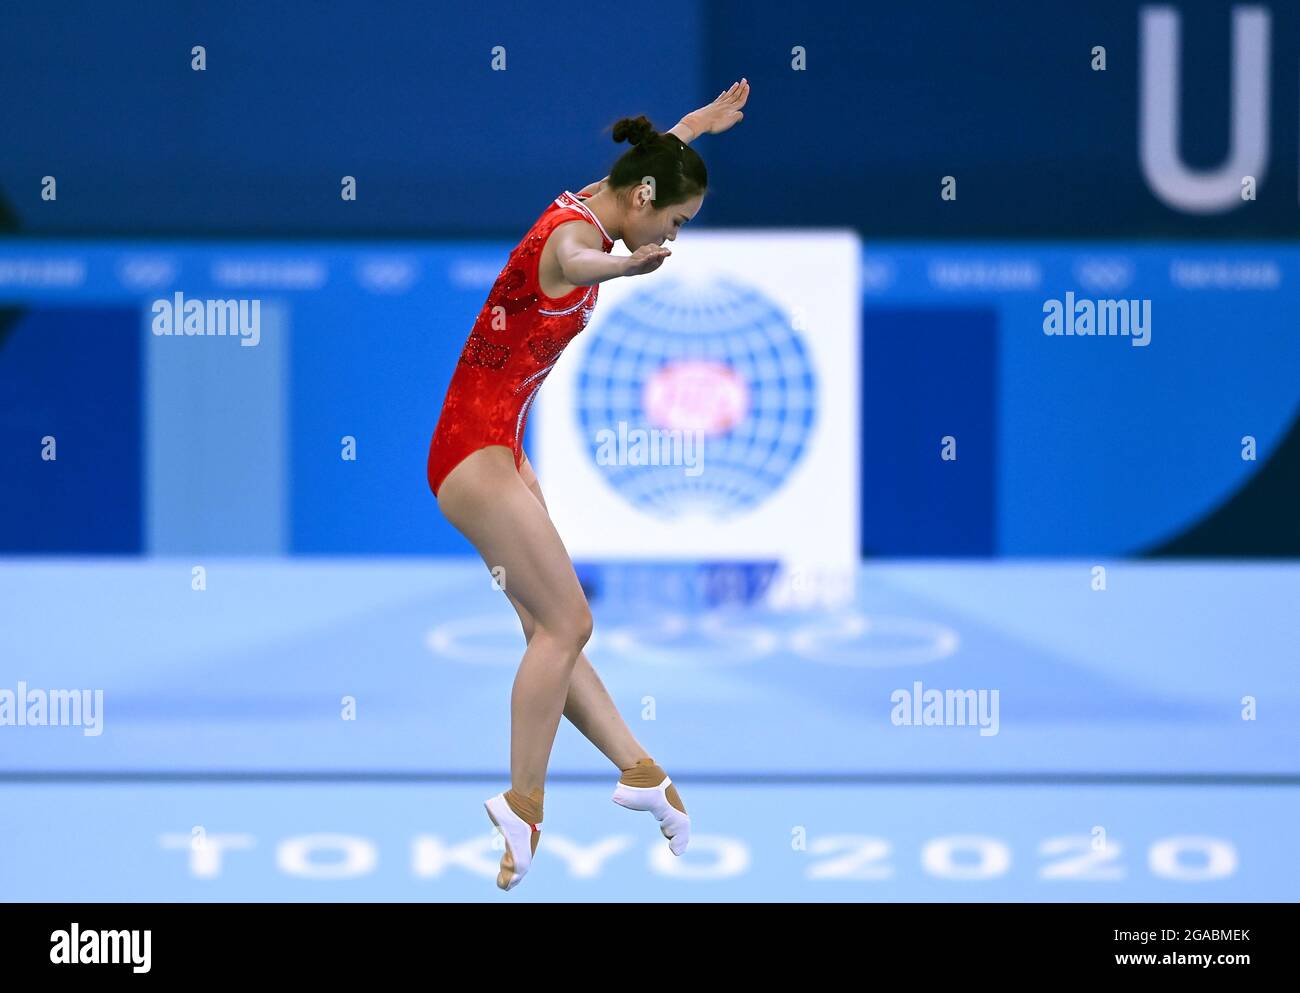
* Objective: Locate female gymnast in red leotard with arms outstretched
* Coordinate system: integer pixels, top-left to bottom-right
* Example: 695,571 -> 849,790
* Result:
428,79 -> 749,890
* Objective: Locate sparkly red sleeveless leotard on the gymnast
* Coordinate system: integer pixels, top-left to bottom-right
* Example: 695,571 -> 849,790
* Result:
429,190 -> 614,495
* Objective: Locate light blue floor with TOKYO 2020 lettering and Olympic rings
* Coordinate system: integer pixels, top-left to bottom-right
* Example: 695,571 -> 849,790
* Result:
0,560 -> 1300,901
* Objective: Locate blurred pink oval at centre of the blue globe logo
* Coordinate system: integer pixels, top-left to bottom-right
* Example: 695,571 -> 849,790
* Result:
641,359 -> 749,434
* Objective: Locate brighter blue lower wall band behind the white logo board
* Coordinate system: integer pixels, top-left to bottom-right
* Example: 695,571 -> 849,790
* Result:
0,242 -> 1300,556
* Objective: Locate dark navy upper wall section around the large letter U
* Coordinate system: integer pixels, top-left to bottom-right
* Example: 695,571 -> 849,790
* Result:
0,0 -> 1300,238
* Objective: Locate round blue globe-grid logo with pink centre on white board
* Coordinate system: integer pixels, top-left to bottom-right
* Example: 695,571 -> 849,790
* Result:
577,278 -> 818,519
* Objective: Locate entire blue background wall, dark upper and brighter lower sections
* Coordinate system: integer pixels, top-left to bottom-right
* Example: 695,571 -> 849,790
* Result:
0,0 -> 1300,556
